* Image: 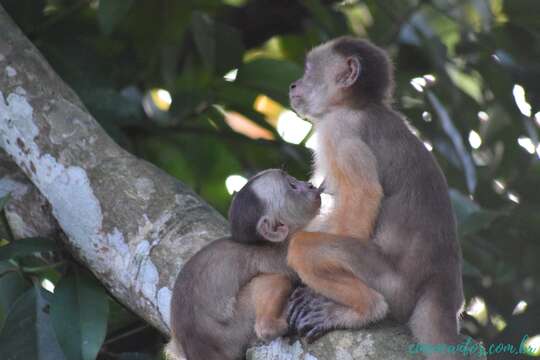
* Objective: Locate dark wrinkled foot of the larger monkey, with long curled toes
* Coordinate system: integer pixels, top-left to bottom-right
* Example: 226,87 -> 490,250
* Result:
287,286 -> 341,343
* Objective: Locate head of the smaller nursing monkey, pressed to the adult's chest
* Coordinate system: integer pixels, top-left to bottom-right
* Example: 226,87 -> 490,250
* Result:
229,169 -> 321,243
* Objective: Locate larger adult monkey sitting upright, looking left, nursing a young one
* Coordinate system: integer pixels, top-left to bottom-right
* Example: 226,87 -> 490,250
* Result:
288,37 -> 463,359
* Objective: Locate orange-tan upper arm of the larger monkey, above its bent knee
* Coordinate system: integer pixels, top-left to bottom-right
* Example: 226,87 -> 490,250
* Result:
328,138 -> 383,242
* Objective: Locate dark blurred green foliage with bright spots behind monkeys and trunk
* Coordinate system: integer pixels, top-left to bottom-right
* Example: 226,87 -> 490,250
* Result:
0,0 -> 540,360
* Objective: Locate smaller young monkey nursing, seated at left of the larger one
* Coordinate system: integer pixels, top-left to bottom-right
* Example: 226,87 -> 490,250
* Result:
167,169 -> 321,360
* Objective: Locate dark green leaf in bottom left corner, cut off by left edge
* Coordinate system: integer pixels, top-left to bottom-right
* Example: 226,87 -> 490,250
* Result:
0,284 -> 66,360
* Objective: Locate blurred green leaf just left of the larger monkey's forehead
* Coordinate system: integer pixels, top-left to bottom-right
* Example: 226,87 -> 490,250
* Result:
236,59 -> 302,105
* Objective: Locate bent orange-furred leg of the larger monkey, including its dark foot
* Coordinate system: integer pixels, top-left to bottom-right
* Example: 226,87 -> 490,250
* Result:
287,232 -> 388,333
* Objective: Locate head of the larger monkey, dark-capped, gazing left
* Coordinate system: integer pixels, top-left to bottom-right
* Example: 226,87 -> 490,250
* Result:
289,36 -> 393,121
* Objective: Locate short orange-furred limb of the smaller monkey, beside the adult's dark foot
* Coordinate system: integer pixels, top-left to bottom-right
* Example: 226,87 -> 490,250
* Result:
250,274 -> 292,341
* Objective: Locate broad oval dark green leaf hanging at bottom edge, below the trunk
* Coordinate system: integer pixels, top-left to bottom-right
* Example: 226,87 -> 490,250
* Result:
51,272 -> 109,360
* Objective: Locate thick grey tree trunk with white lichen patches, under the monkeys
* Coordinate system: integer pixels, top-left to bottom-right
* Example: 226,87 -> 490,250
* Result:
0,7 -> 480,359
